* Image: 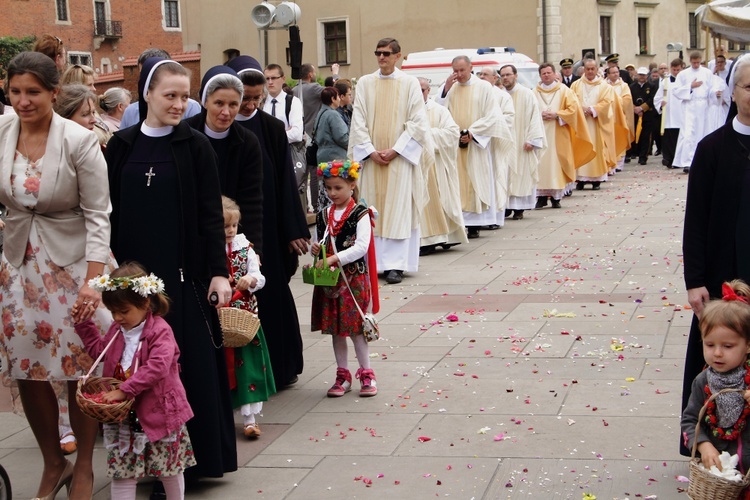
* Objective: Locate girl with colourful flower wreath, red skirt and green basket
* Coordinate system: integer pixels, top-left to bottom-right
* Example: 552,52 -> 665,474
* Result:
311,161 -> 379,397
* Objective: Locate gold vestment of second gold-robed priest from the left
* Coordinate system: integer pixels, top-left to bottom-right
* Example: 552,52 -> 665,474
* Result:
570,77 -> 617,180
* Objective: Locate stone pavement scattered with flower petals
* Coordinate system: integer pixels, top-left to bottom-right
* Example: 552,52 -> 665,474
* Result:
0,157 -> 691,500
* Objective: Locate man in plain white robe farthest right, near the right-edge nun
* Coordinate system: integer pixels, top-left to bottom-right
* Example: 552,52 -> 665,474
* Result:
671,51 -> 718,173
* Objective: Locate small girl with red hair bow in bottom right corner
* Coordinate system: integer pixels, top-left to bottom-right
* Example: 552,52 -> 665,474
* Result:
682,280 -> 750,471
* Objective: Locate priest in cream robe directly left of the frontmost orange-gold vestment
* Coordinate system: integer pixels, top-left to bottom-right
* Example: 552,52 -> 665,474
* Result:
500,64 -> 547,220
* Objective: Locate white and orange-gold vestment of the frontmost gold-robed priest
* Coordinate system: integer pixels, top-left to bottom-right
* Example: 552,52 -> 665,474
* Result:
534,82 -> 596,190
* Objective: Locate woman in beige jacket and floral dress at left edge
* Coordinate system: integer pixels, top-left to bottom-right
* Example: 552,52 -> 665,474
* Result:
0,52 -> 111,499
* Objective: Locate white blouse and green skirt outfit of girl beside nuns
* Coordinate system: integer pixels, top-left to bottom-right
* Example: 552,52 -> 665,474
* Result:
225,234 -> 276,406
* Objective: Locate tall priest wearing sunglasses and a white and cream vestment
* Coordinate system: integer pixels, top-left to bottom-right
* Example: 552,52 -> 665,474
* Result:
348,38 -> 434,284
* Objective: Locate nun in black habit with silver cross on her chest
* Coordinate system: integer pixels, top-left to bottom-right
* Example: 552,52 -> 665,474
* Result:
105,58 -> 237,478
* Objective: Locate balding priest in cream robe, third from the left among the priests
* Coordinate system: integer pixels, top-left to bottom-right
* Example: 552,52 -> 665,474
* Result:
436,56 -> 515,238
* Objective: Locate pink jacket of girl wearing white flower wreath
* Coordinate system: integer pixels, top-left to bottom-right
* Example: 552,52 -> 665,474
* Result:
75,312 -> 193,443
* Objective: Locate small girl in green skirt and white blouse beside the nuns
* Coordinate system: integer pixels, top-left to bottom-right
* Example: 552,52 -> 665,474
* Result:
221,196 -> 276,439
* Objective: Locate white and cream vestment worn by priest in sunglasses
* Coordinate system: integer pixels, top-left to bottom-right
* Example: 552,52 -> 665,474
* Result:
348,69 -> 434,240
